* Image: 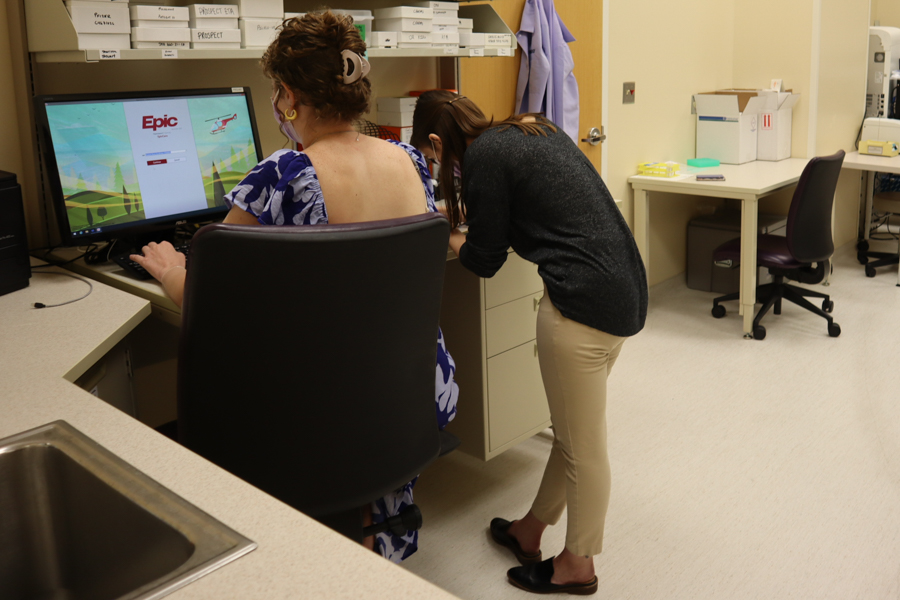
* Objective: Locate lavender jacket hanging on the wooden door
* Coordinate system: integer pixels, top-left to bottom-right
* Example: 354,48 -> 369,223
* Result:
516,0 -> 578,144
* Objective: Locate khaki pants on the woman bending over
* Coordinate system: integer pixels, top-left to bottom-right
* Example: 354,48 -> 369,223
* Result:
532,288 -> 626,556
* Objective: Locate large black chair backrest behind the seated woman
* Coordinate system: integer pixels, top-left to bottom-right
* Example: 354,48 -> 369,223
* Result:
178,214 -> 449,517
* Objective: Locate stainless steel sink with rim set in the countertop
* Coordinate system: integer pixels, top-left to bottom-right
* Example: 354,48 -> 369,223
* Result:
0,421 -> 256,600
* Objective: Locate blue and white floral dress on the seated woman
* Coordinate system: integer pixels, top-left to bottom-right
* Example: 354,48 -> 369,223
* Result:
225,141 -> 459,563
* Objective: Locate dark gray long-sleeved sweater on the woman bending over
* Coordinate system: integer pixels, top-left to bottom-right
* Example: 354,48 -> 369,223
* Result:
459,127 -> 647,337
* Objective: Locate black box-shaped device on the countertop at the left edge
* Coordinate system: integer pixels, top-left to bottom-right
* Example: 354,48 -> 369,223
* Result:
0,171 -> 31,296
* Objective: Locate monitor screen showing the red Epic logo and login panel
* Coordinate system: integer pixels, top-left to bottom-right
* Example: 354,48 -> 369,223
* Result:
47,94 -> 259,232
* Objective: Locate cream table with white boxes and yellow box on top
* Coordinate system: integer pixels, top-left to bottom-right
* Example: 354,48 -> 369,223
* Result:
628,158 -> 808,337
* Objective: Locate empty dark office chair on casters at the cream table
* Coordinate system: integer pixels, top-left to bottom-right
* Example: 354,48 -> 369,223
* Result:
712,150 -> 844,340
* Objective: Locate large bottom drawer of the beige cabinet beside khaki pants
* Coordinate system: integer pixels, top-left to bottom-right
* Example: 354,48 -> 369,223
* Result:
487,341 -> 550,450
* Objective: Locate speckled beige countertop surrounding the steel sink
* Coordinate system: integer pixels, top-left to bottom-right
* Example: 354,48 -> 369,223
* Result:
0,269 -> 454,600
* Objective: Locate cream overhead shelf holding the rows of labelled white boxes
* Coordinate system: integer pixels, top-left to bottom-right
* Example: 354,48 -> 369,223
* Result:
25,0 -> 516,63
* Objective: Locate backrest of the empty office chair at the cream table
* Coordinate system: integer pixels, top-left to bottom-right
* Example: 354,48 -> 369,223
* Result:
785,150 -> 844,263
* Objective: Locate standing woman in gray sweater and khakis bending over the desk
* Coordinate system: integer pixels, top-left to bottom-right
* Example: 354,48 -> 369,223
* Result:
411,90 -> 647,594
